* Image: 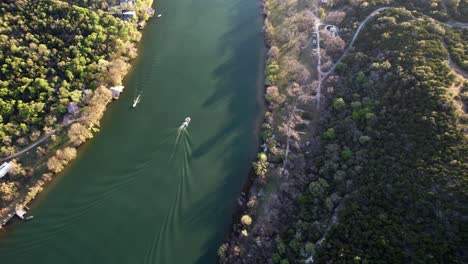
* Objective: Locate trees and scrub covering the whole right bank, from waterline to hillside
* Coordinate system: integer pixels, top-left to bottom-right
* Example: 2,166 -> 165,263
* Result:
220,1 -> 468,264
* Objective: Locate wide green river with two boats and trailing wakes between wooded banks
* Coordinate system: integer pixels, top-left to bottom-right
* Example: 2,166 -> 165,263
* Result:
0,0 -> 264,264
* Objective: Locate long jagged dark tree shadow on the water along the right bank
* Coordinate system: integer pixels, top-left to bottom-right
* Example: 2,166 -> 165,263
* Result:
189,1 -> 264,264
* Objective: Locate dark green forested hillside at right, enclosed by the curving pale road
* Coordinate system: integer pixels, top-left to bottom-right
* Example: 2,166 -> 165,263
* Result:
274,9 -> 468,263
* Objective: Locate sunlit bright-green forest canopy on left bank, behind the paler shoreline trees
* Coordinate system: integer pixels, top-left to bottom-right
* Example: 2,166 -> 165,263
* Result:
0,0 -> 139,157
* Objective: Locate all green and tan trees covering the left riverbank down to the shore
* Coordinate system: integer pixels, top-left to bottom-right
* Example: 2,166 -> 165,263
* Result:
0,0 -> 152,222
